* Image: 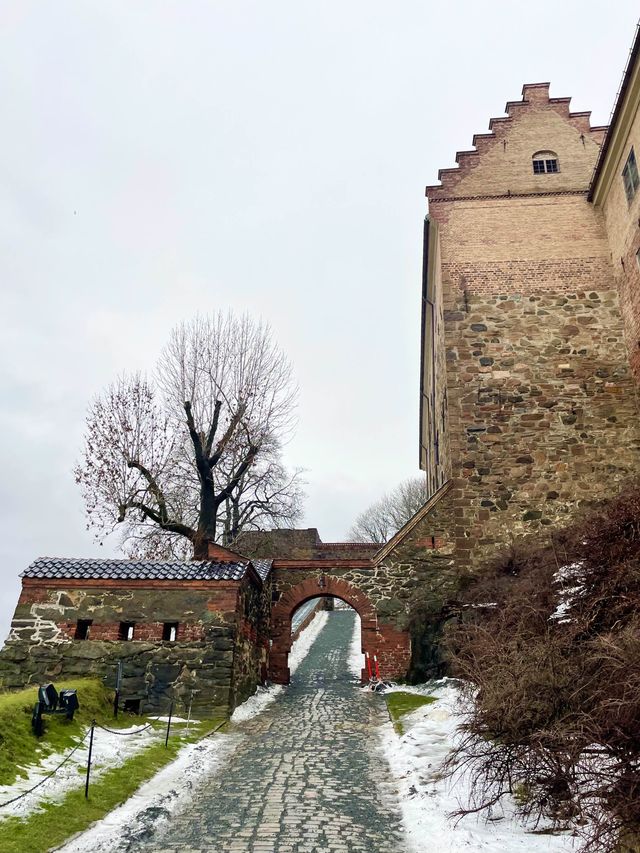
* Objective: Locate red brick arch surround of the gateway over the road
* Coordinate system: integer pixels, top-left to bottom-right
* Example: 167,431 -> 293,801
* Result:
269,575 -> 378,684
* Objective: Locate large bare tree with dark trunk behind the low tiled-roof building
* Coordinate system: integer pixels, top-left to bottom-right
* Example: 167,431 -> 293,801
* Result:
75,312 -> 302,557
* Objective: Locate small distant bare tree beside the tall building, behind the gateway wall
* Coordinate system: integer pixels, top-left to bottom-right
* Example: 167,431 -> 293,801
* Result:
349,477 -> 428,542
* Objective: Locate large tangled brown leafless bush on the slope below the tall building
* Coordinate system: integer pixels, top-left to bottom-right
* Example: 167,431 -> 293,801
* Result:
445,484 -> 640,853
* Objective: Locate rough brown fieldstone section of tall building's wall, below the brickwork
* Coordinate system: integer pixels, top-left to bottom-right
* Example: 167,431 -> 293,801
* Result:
446,290 -> 640,548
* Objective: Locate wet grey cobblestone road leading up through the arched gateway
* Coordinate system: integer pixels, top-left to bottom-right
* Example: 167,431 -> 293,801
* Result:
145,611 -> 405,853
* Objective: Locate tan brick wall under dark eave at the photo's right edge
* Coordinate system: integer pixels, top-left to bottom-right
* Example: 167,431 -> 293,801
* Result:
603,98 -> 640,382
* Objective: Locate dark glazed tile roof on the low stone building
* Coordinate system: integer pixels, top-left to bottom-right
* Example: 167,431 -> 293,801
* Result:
22,557 -> 249,581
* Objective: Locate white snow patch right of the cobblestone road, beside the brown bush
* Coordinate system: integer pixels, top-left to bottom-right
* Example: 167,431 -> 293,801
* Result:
380,680 -> 574,853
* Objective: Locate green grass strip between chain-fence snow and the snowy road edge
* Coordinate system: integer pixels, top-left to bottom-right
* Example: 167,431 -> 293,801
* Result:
0,720 -> 223,853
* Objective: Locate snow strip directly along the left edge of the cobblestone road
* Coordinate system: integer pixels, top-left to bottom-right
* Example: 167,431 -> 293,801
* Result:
58,734 -> 238,853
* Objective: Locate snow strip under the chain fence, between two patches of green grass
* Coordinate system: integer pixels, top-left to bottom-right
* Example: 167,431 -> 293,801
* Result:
0,724 -> 164,825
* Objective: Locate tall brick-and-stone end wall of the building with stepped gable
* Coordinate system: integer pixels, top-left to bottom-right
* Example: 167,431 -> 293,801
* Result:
402,85 -> 640,676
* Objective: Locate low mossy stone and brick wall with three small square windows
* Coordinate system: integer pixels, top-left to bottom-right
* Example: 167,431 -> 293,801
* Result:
0,578 -> 245,714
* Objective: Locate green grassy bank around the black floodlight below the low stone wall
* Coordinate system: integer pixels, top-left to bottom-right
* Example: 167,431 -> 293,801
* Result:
0,678 -> 141,785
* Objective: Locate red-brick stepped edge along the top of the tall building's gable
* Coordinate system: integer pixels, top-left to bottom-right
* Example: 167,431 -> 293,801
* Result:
425,83 -> 607,201
